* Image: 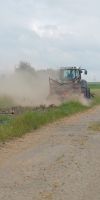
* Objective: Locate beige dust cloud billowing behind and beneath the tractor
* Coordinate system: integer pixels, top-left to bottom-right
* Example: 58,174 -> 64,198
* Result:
0,63 -> 90,106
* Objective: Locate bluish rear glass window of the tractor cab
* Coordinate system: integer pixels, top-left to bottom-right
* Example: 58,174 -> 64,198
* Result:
64,69 -> 76,80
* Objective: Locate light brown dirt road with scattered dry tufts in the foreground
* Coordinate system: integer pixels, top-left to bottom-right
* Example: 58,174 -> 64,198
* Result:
0,107 -> 100,200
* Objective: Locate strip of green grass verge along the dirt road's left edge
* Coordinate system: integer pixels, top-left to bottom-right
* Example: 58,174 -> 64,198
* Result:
0,102 -> 87,141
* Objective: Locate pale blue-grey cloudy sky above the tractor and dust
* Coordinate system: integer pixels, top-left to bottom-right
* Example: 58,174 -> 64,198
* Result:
0,0 -> 100,81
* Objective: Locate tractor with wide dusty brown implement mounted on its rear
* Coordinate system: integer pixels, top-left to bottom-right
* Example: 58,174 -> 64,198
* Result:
49,67 -> 91,100
